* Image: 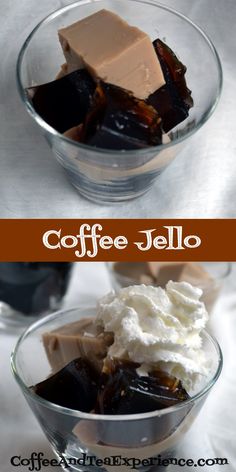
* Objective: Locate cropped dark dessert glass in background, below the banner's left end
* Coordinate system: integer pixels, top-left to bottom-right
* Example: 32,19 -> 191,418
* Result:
0,262 -> 72,327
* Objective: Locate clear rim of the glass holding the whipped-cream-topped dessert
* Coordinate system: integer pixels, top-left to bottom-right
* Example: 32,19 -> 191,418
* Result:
11,306 -> 223,421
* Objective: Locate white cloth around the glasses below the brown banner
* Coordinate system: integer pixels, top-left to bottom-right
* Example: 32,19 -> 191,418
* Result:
0,263 -> 236,472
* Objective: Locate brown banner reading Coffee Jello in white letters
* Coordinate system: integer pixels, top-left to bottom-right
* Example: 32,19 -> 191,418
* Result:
0,219 -> 236,262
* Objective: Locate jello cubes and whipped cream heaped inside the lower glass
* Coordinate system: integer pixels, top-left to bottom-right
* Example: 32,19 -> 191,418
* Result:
32,281 -> 209,415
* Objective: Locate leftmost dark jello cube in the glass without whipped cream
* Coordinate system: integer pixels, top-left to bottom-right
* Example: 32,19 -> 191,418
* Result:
27,69 -> 96,133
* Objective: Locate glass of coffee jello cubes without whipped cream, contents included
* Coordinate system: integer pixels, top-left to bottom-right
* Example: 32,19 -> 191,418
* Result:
17,0 -> 222,203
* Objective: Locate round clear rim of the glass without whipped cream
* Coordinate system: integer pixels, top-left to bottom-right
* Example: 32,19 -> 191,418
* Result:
16,0 -> 223,157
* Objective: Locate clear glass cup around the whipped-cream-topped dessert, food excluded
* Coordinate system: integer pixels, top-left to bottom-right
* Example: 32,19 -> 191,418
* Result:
11,308 -> 222,471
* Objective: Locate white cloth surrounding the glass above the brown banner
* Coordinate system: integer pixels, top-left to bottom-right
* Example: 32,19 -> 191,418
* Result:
0,0 -> 236,218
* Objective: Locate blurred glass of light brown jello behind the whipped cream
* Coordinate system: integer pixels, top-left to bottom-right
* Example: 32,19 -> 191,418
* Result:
107,261 -> 231,313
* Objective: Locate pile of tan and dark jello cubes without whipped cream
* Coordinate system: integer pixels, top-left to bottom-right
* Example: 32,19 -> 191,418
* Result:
27,10 -> 193,150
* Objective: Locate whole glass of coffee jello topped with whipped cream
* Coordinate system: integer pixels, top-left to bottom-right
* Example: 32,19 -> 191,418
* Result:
12,281 -> 222,471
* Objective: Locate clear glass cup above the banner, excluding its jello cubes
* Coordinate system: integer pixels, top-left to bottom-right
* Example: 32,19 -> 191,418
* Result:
17,0 -> 222,203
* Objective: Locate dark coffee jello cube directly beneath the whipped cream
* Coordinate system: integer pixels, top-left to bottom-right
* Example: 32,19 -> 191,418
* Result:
96,362 -> 191,447
